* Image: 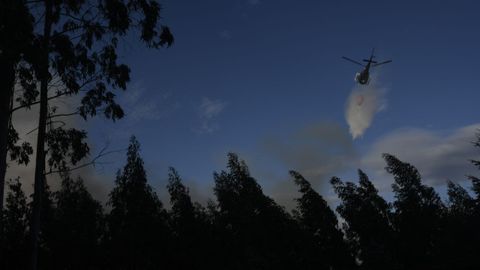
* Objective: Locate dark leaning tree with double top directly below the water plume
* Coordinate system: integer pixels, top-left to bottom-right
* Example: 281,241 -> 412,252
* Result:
330,170 -> 398,269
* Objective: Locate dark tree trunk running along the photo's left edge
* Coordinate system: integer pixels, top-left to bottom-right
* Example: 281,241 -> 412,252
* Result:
0,58 -> 15,262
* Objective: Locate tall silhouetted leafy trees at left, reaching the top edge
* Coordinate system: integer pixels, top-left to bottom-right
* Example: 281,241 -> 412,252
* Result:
0,0 -> 173,269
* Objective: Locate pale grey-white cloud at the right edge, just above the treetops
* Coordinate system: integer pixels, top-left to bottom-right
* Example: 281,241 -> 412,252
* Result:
361,124 -> 480,189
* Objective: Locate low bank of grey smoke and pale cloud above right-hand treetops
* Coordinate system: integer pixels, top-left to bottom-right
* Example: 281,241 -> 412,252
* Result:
255,123 -> 480,209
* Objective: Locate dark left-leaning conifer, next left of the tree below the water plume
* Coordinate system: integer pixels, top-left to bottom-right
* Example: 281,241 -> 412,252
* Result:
290,171 -> 355,269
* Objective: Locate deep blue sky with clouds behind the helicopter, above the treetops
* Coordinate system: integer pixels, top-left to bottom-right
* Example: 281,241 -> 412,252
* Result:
83,0 -> 480,207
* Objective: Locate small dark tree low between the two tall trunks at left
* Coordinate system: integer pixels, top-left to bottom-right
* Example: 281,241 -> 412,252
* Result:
0,178 -> 28,269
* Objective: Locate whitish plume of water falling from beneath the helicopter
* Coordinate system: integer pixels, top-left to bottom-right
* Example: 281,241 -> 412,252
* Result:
345,78 -> 386,139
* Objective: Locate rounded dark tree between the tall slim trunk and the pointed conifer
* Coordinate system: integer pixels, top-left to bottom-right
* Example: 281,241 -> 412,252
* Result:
47,176 -> 104,269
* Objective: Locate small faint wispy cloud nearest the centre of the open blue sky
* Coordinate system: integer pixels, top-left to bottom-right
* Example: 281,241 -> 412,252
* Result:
197,97 -> 227,133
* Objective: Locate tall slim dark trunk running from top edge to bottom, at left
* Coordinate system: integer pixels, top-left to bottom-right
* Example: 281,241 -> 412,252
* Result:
30,0 -> 52,270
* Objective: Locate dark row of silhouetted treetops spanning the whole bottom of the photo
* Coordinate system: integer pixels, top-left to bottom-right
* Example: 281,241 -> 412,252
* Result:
0,137 -> 480,269
